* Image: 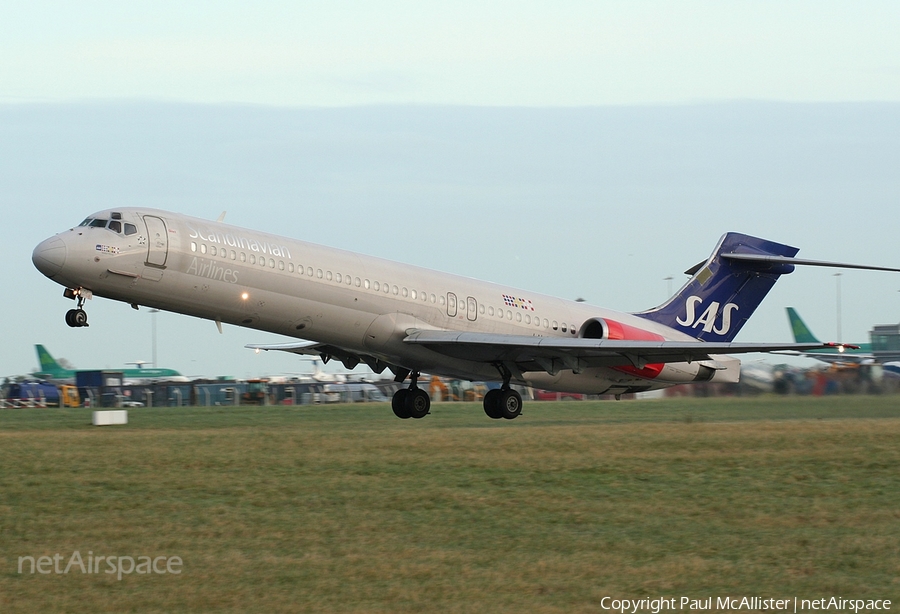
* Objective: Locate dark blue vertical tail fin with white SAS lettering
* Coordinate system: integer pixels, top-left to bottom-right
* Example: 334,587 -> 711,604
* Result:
635,232 -> 800,341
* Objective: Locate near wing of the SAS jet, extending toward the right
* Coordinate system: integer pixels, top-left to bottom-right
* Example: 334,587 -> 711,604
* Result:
404,330 -> 849,371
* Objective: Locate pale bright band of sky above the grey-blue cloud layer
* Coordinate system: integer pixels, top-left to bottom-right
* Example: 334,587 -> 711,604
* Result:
0,0 -> 900,106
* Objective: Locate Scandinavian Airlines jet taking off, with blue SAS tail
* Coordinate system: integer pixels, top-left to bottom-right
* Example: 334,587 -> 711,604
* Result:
32,207 -> 900,419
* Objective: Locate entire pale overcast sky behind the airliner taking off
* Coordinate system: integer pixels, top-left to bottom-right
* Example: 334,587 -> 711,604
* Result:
0,1 -> 900,376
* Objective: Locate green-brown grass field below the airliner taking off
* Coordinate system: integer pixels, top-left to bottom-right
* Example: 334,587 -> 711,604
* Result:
0,397 -> 900,613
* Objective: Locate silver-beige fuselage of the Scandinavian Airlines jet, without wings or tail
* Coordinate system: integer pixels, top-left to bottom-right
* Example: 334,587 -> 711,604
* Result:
33,208 -> 739,400
